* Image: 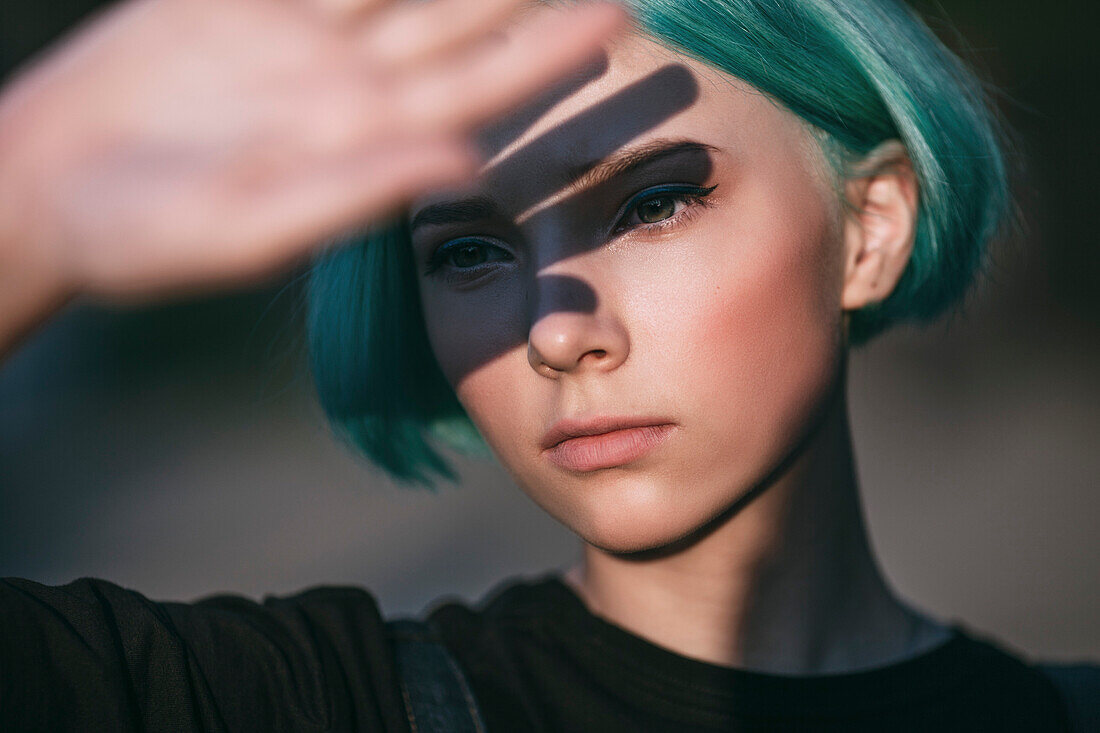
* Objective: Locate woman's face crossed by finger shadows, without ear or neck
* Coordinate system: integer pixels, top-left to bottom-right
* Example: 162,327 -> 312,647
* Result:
411,31 -> 844,551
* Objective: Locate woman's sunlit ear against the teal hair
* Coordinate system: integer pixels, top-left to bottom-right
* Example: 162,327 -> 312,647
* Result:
840,140 -> 919,310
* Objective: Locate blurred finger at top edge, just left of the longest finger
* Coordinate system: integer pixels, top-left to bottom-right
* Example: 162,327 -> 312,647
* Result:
360,0 -> 529,68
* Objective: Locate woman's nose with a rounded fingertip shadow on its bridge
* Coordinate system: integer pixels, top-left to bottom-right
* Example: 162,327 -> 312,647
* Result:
527,275 -> 630,379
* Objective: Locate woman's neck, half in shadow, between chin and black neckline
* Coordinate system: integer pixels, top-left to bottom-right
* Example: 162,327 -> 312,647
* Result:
567,389 -> 947,675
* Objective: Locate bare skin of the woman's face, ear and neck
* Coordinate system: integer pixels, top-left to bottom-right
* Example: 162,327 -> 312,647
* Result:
411,35 -> 946,674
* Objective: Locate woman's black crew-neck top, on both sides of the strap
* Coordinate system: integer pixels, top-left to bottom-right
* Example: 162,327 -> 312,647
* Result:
0,577 -> 1082,733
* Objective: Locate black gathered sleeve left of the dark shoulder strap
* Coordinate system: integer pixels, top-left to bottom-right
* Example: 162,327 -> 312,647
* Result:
0,579 -> 408,733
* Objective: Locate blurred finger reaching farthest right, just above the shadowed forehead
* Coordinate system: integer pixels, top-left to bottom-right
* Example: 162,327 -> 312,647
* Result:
394,3 -> 626,130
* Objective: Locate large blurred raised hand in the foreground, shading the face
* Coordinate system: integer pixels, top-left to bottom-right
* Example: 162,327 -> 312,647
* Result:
0,0 -> 623,302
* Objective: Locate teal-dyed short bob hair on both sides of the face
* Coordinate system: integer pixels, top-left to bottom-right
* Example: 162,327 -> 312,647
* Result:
307,0 -> 1009,486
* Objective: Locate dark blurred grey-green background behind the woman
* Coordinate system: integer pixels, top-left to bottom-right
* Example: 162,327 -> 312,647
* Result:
0,0 -> 1100,660
